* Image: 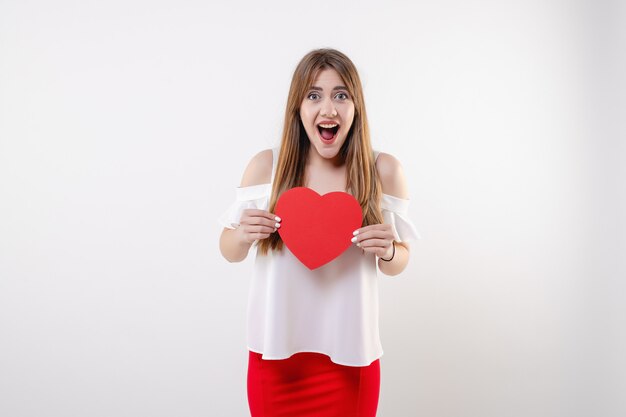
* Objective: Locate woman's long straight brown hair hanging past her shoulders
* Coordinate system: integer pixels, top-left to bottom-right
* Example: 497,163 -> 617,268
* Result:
258,48 -> 383,255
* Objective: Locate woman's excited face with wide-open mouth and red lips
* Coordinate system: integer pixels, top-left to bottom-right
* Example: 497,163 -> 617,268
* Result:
300,68 -> 354,159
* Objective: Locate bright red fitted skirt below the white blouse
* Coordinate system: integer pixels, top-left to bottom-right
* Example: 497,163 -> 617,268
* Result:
248,352 -> 380,417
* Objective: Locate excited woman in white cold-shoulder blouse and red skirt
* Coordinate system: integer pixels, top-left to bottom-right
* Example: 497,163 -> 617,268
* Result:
220,49 -> 419,417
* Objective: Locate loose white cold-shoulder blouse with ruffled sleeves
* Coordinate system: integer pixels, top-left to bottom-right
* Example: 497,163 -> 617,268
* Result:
220,149 -> 421,366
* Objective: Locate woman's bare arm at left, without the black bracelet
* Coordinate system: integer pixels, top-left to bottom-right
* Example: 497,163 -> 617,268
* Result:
220,149 -> 277,262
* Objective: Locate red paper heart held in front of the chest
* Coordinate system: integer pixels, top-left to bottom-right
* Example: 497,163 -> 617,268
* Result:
274,187 -> 363,270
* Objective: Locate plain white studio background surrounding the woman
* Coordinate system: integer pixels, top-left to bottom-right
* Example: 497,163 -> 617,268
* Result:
0,0 -> 626,417
